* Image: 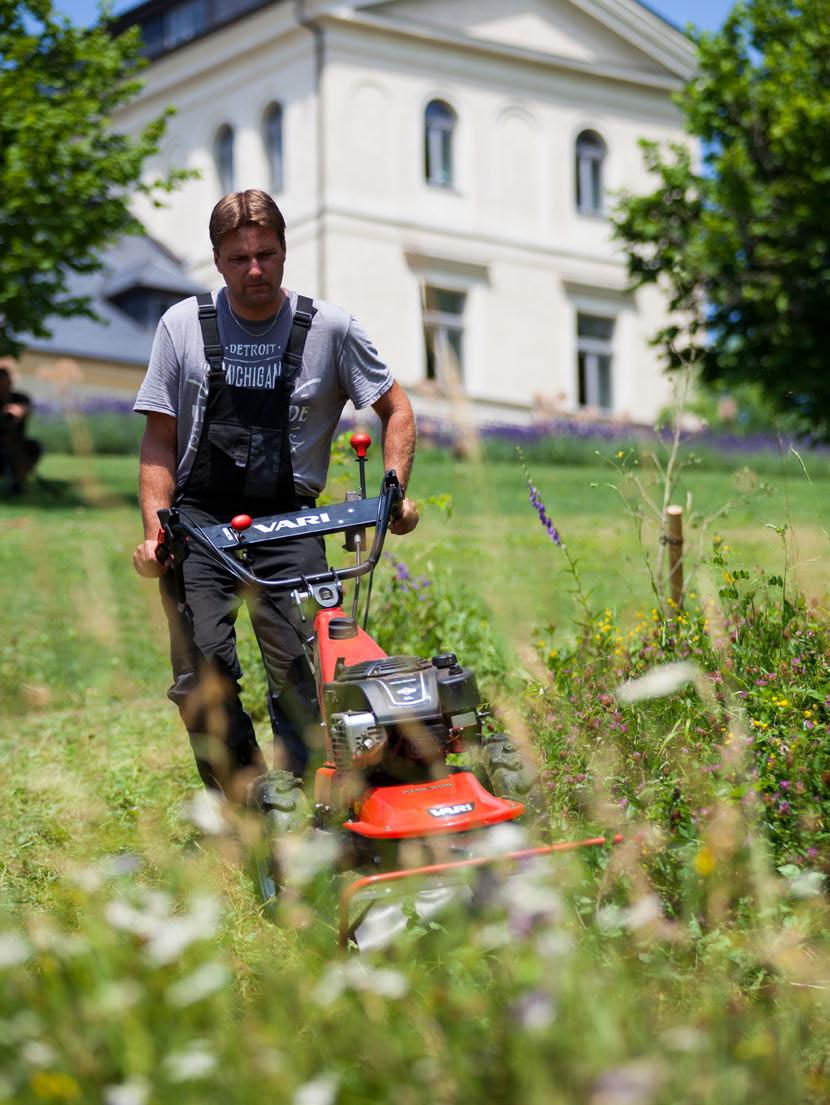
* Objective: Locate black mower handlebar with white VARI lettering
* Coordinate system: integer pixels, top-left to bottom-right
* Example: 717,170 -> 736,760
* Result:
156,470 -> 403,591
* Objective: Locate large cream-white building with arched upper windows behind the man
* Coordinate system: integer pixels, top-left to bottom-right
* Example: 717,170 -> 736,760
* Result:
112,0 -> 693,421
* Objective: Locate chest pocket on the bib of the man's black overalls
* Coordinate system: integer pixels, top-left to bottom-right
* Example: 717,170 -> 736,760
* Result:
208,422 -> 284,499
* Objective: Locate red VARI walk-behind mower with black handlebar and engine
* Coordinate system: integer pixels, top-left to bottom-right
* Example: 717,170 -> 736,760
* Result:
159,433 -> 618,948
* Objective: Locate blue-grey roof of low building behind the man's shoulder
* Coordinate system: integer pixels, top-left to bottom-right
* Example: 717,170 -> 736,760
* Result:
23,234 -> 204,365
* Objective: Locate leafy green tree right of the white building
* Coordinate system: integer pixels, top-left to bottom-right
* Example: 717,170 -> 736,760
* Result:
613,0 -> 830,439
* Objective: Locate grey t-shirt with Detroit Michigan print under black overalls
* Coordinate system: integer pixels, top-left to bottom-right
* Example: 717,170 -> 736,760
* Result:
133,288 -> 393,496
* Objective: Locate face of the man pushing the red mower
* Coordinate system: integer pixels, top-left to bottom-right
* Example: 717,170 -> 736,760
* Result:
213,227 -> 285,319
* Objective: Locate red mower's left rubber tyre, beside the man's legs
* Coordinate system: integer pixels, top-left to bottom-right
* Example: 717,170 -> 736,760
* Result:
250,771 -> 311,920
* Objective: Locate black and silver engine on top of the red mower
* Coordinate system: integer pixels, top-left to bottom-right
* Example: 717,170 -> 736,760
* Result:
324,653 -> 481,779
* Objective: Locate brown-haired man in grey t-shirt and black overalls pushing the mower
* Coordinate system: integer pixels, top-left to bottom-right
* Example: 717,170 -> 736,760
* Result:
134,190 -> 418,798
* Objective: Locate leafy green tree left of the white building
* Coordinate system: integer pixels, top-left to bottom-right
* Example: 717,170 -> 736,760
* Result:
0,0 -> 185,356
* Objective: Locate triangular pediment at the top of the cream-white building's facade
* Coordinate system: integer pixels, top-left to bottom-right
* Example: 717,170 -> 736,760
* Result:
350,0 -> 693,77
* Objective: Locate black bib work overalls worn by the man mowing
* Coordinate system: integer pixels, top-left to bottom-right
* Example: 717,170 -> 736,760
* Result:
161,295 -> 326,790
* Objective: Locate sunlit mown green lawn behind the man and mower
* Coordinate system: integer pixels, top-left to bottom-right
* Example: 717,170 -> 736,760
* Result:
0,452 -> 830,914
